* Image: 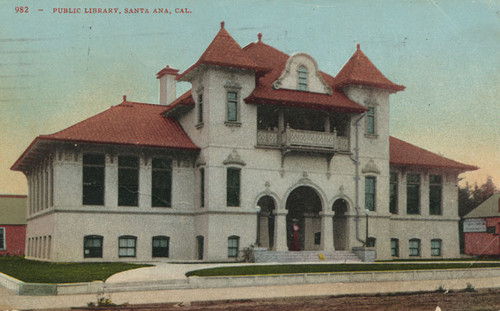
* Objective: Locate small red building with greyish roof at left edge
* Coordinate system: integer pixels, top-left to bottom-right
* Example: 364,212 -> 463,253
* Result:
0,194 -> 27,256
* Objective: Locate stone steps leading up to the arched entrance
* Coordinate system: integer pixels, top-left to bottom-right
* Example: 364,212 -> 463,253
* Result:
254,249 -> 362,263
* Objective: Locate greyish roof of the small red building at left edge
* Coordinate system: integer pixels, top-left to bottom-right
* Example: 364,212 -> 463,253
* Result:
0,194 -> 27,226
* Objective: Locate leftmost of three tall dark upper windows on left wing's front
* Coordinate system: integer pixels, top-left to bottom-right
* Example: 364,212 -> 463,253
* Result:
82,154 -> 106,205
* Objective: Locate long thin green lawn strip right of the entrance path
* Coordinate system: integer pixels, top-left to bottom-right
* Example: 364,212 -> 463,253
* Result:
186,262 -> 500,277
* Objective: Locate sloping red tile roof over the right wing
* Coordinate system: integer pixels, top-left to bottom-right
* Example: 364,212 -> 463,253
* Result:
389,137 -> 479,171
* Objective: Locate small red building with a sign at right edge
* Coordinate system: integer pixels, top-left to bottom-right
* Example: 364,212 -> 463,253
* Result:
464,193 -> 500,257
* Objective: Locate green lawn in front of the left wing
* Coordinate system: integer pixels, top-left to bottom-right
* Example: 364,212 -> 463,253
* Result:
0,257 -> 149,283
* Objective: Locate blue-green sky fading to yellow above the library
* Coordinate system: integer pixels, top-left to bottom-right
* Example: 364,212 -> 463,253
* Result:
0,0 -> 500,194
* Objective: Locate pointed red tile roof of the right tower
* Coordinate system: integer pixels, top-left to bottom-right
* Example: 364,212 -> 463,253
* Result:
333,44 -> 405,93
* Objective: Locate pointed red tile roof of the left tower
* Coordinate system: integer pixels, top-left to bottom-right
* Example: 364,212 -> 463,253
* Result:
177,22 -> 265,79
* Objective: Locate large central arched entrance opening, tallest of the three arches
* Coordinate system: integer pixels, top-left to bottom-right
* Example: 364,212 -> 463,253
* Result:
286,186 -> 322,251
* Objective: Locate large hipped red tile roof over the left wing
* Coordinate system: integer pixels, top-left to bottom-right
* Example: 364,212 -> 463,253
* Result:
11,100 -> 199,170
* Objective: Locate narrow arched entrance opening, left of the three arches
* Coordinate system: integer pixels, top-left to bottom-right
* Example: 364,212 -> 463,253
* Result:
257,195 -> 276,250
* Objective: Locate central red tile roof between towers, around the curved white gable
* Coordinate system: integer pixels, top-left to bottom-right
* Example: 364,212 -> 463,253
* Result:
243,36 -> 366,113
